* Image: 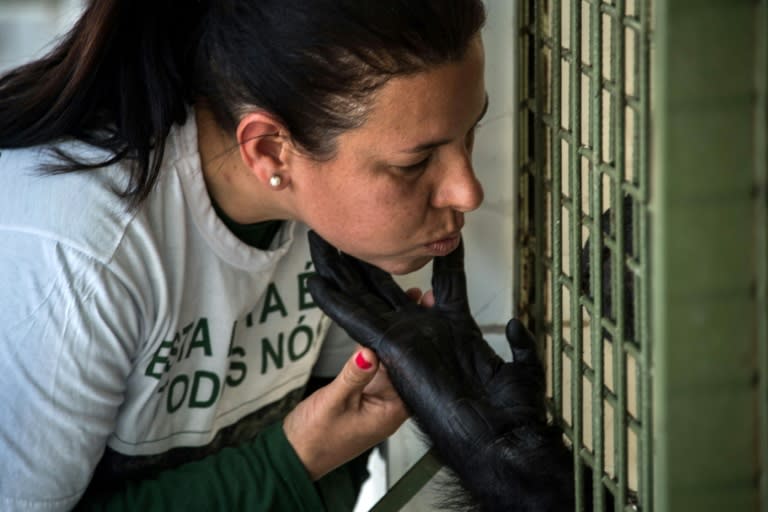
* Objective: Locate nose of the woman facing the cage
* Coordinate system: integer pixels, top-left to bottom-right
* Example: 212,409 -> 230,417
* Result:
432,153 -> 484,213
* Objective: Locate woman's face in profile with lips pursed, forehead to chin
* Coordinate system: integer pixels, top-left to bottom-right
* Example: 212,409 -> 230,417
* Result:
291,37 -> 487,274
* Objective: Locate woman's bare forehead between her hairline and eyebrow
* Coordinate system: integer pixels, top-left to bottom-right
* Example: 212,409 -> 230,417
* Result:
339,37 -> 486,150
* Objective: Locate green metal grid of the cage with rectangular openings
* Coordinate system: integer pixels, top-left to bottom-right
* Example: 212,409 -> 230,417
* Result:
516,0 -> 653,510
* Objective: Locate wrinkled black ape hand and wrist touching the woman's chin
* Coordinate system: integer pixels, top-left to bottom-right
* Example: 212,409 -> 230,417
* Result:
309,232 -> 574,512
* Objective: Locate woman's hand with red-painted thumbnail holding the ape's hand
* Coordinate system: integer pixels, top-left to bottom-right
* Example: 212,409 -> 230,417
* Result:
283,348 -> 408,480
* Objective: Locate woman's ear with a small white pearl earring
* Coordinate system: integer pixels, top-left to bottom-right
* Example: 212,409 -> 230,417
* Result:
236,111 -> 289,188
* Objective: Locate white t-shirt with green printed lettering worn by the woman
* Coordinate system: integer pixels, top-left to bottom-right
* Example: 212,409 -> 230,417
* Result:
0,116 -> 353,510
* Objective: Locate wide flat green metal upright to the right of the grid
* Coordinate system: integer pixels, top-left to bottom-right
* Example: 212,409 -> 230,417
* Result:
651,0 -> 765,512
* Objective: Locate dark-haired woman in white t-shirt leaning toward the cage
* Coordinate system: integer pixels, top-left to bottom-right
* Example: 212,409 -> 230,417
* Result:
0,0 -> 487,511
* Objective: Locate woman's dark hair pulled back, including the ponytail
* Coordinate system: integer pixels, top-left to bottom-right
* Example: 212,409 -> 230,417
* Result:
0,0 -> 485,206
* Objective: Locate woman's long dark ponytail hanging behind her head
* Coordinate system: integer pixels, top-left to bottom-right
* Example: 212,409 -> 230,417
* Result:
0,0 -> 202,207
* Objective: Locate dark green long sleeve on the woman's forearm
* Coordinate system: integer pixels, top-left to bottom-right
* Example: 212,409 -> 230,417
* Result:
75,422 -> 326,512
